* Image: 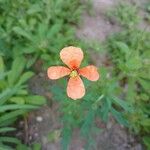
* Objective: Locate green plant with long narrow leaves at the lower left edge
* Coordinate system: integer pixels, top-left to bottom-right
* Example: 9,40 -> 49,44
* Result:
0,56 -> 46,149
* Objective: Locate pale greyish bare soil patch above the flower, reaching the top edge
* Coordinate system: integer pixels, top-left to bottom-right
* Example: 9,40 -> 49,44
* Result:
77,0 -> 121,41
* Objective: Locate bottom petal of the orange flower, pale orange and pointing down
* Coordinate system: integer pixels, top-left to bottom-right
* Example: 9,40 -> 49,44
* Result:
67,76 -> 85,100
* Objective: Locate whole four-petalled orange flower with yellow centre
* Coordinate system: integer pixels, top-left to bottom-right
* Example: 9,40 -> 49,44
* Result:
47,46 -> 99,100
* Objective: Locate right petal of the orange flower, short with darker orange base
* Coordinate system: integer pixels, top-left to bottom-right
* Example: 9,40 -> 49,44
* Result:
79,65 -> 99,81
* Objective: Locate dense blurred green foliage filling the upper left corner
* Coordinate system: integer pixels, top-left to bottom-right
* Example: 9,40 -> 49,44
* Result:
0,0 -> 82,67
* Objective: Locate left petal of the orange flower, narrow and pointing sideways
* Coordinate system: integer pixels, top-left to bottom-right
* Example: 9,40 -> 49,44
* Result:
47,66 -> 71,80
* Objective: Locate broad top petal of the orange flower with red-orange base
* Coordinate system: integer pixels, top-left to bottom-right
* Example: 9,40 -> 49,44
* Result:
60,46 -> 83,69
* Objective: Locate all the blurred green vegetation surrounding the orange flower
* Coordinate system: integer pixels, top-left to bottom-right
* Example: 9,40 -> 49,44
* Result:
0,0 -> 150,150
